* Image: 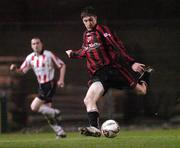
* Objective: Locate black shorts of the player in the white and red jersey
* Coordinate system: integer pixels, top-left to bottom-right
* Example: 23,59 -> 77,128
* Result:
38,80 -> 56,103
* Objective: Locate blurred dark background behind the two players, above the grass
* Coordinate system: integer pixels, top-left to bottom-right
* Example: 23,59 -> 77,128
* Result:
0,0 -> 180,129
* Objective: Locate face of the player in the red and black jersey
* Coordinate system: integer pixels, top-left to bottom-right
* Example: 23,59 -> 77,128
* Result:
82,16 -> 97,31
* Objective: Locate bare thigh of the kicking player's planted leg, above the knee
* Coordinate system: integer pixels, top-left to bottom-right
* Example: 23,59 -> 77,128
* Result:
85,81 -> 104,101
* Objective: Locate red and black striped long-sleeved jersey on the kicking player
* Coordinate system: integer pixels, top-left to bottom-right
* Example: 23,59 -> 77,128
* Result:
70,25 -> 134,74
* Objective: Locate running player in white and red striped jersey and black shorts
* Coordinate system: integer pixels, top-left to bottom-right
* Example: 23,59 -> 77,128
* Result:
10,37 -> 66,138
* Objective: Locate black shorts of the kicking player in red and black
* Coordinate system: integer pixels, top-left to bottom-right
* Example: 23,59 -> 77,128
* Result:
90,66 -> 137,93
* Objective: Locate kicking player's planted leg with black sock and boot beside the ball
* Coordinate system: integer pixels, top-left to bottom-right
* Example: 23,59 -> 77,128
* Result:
80,81 -> 104,137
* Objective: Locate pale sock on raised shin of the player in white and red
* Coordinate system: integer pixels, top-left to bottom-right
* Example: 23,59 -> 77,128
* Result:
38,105 -> 55,118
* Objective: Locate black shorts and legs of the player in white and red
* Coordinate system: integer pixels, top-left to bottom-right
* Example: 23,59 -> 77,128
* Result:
31,81 -> 66,138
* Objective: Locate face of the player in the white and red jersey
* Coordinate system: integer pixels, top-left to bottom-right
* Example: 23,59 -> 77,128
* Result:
31,39 -> 43,53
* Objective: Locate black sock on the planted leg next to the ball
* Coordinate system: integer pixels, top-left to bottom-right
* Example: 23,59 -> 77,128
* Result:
88,111 -> 99,128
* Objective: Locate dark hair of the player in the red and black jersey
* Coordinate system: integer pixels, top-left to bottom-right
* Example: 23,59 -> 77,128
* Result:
81,6 -> 97,19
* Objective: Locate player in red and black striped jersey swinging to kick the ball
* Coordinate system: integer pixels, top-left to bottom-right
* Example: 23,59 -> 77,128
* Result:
66,7 -> 152,137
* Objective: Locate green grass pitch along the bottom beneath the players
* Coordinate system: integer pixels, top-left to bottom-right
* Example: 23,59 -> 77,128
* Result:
0,129 -> 180,148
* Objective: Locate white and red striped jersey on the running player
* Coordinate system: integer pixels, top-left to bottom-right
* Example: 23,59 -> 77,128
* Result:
20,50 -> 64,84
